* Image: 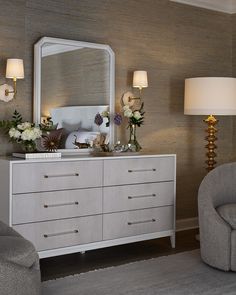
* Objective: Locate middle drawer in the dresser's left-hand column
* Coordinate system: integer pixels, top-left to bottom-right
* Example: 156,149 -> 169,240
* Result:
12,188 -> 102,224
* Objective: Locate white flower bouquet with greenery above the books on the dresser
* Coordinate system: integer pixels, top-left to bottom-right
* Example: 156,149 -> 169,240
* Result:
0,111 -> 42,152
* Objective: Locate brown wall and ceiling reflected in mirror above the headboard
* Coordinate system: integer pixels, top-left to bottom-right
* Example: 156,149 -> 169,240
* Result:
41,43 -> 110,116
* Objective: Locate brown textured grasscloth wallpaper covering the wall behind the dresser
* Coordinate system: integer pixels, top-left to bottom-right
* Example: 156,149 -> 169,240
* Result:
0,0 -> 236,219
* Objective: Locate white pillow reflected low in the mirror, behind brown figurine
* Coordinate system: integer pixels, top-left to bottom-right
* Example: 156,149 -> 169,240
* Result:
65,131 -> 100,149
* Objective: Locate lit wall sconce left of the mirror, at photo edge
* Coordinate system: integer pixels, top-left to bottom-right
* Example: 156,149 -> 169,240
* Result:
0,58 -> 24,102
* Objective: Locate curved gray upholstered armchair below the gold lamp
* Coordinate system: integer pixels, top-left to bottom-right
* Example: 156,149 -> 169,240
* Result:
198,163 -> 236,271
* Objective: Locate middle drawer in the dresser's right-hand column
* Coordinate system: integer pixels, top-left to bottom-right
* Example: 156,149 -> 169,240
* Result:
103,181 -> 174,213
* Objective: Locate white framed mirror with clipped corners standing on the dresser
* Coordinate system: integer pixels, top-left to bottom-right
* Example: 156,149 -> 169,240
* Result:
34,37 -> 115,153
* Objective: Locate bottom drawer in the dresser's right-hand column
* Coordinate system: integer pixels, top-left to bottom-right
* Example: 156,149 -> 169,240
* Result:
103,206 -> 174,240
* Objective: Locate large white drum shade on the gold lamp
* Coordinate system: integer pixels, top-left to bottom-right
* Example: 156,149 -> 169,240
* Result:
184,77 -> 236,115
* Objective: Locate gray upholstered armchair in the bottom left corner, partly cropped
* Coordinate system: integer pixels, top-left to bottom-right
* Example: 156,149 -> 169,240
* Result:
0,222 -> 41,295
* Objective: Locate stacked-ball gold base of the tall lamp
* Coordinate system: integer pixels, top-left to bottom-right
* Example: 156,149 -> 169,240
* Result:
204,115 -> 218,172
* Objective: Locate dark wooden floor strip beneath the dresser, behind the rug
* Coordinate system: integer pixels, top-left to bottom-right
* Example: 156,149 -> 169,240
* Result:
40,230 -> 199,281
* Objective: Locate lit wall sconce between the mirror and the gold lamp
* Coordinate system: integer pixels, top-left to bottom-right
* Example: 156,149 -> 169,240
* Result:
121,71 -> 148,106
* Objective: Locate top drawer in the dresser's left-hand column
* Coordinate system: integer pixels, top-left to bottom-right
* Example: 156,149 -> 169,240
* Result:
13,160 -> 102,194
